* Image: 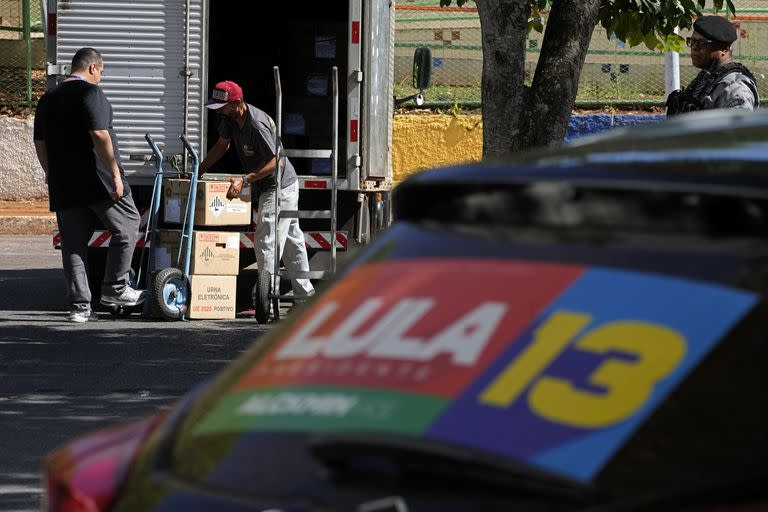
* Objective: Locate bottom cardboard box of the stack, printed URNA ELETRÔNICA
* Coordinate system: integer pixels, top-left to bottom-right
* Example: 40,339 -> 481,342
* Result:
187,275 -> 237,320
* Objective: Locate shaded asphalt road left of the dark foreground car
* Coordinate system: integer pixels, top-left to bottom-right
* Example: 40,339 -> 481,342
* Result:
0,236 -> 268,512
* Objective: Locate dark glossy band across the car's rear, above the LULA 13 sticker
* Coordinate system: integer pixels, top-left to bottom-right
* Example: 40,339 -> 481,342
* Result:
394,181 -> 768,238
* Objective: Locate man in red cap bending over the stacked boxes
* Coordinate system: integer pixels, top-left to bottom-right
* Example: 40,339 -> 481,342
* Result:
200,82 -> 315,297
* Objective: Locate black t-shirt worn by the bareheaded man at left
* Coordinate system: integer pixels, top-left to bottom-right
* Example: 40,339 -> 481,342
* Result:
35,80 -> 130,211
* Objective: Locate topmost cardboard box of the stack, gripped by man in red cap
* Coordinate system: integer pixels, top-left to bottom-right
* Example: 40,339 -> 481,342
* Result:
163,179 -> 251,226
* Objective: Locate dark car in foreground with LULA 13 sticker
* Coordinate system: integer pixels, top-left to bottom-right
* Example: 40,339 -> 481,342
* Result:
40,109 -> 768,512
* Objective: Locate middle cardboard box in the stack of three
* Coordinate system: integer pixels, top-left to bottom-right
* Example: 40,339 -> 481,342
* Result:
155,231 -> 240,276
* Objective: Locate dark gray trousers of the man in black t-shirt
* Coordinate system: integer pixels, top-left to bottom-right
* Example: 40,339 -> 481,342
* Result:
56,195 -> 141,310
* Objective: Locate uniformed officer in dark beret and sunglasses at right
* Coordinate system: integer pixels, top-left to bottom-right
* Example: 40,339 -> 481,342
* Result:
667,16 -> 759,117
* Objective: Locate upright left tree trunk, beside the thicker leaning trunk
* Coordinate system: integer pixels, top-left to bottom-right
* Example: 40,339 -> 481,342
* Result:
475,0 -> 530,159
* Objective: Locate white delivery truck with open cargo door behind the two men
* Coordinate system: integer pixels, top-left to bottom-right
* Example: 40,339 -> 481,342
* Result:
43,0 -> 431,314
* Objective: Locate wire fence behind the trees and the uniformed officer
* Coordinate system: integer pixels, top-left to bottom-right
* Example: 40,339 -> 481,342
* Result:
395,0 -> 768,107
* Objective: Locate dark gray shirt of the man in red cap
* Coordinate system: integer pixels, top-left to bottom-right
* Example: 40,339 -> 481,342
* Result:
219,103 -> 297,193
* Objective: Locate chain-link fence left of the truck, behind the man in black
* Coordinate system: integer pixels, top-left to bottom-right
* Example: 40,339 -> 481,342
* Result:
0,0 -> 45,106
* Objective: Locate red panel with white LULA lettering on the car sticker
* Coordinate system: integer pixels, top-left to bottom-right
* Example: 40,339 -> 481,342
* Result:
236,259 -> 583,398
